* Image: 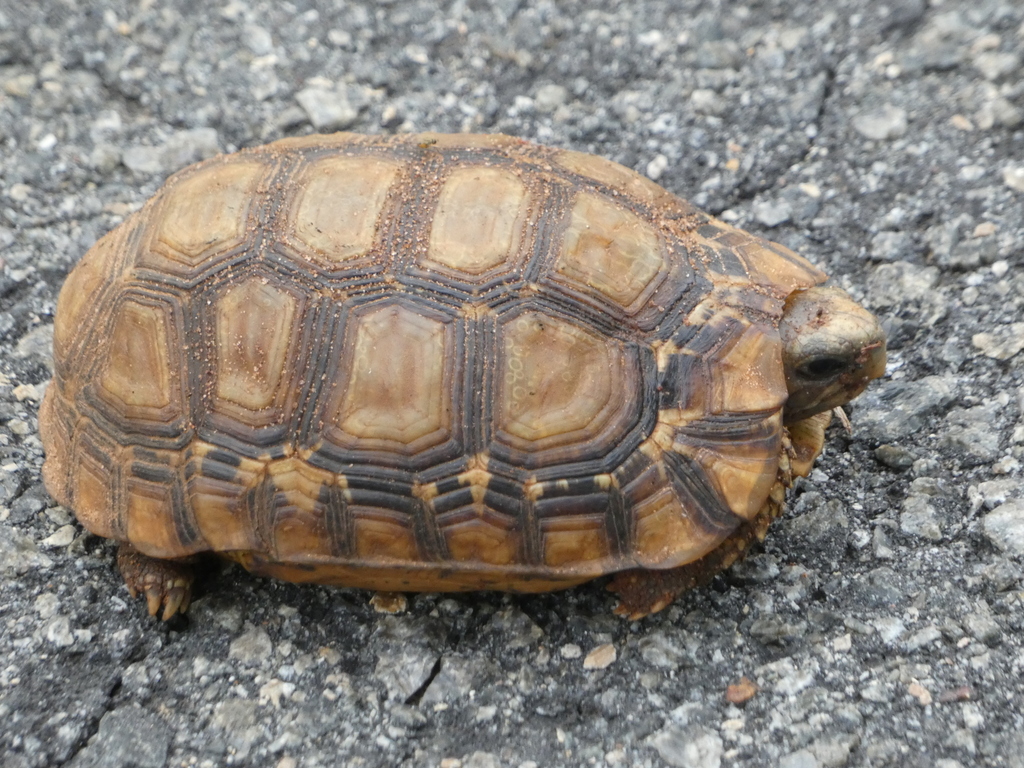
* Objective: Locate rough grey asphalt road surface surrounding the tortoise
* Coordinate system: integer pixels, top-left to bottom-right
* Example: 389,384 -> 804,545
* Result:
0,0 -> 1024,768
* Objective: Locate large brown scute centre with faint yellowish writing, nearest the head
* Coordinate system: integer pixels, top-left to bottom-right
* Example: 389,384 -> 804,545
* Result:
497,311 -> 639,460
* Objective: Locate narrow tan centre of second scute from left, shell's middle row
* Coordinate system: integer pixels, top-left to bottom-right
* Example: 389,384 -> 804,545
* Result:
216,276 -> 298,411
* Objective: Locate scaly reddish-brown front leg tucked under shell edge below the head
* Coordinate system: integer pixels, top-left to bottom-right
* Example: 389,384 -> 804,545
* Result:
608,412 -> 831,621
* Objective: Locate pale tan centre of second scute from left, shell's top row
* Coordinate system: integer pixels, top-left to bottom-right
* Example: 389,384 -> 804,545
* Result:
292,156 -> 401,268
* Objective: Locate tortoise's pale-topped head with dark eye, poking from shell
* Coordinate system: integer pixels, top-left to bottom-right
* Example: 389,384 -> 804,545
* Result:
779,286 -> 886,424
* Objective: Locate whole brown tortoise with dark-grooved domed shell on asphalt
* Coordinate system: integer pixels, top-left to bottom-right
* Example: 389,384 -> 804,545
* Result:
40,133 -> 886,620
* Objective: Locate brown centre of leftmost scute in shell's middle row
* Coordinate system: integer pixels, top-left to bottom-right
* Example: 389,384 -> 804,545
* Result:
99,299 -> 180,422
